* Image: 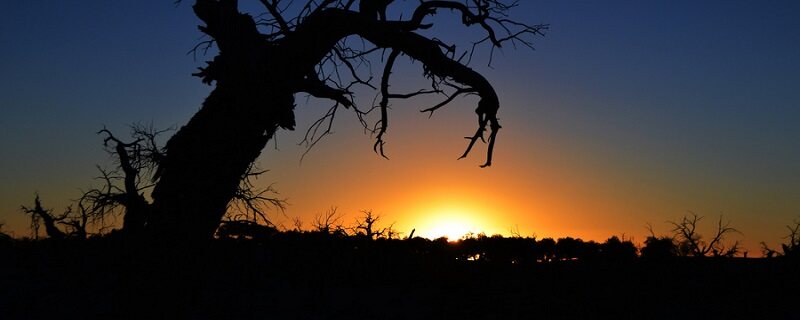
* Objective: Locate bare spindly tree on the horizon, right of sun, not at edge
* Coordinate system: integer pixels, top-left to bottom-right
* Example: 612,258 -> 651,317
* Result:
669,212 -> 740,257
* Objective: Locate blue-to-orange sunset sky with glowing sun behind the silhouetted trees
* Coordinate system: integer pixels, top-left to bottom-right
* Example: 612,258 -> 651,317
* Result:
0,0 -> 800,252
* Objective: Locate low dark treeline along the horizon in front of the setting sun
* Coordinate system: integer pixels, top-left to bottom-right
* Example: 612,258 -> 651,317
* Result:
208,210 -> 800,264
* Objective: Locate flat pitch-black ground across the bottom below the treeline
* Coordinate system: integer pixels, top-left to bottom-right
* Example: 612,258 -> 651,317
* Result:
0,239 -> 800,319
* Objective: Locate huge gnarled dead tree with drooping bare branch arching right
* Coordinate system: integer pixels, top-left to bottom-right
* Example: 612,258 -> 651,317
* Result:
115,0 -> 546,242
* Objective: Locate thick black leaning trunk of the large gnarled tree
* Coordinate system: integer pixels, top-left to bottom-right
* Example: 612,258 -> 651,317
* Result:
145,1 -> 294,243
